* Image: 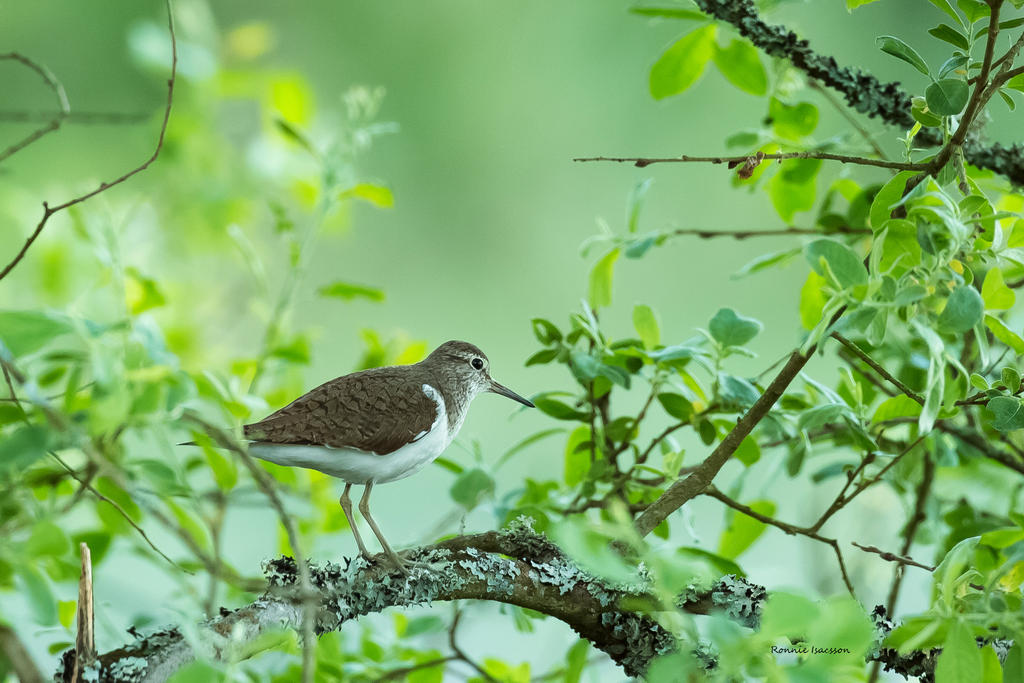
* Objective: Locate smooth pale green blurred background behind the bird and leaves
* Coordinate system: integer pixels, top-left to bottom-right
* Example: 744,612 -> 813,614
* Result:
0,0 -> 1019,677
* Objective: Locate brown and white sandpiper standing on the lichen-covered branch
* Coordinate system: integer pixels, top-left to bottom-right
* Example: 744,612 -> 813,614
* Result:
239,341 -> 534,571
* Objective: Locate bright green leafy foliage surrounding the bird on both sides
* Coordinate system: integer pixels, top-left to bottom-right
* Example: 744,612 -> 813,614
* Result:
0,0 -> 1024,682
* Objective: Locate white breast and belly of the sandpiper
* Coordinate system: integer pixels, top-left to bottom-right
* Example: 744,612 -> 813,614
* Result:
249,384 -> 455,483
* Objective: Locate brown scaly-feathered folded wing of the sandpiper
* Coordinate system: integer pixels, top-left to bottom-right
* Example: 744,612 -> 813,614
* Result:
245,368 -> 437,456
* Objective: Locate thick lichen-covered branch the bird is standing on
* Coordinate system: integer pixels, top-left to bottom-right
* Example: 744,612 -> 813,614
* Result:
56,525 -> 765,683
